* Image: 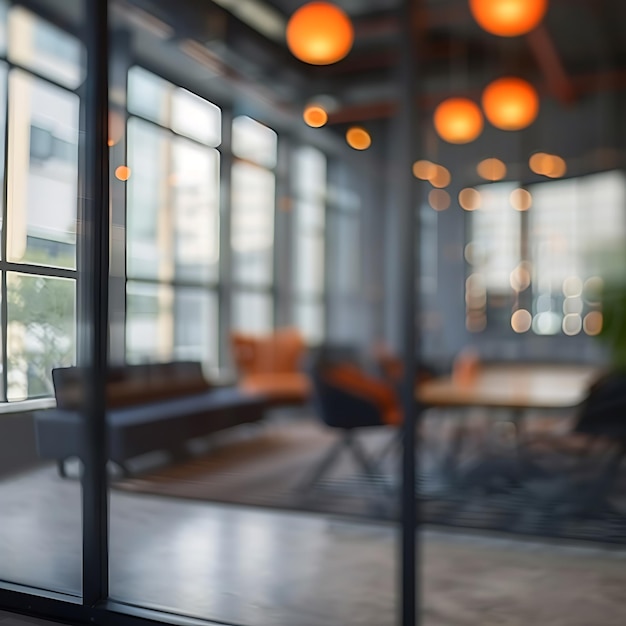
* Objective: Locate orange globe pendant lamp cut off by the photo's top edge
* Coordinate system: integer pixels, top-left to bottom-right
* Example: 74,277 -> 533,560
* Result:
469,0 -> 548,37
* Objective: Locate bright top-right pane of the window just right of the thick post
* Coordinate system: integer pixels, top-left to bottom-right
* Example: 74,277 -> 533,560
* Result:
172,89 -> 222,146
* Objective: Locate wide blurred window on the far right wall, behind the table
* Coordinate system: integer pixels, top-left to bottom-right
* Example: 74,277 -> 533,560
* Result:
466,171 -> 626,336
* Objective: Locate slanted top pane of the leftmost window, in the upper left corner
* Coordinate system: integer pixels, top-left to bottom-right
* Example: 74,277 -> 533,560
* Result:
9,6 -> 85,89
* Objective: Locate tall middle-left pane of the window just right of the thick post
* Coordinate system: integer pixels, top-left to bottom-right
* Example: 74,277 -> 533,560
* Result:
126,118 -> 173,279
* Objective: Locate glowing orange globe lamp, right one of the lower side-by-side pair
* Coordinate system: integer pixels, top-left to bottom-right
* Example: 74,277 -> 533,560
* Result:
482,77 -> 539,130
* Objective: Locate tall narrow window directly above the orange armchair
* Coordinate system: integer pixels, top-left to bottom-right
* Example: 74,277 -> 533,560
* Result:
230,116 -> 277,332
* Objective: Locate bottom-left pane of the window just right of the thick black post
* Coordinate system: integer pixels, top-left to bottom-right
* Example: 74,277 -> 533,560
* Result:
126,282 -> 174,363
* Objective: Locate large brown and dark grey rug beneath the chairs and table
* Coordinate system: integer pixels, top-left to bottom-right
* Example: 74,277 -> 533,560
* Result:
112,419 -> 626,544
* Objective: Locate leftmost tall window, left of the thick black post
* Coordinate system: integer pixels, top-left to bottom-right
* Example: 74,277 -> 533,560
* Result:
0,3 -> 84,400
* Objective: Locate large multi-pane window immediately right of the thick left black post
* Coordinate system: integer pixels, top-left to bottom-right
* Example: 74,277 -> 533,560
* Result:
126,67 -> 221,367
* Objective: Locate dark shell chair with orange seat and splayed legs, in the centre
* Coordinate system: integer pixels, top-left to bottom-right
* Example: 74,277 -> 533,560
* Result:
300,348 -> 401,491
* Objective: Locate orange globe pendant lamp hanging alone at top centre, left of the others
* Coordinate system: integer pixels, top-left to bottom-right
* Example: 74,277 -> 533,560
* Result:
287,2 -> 354,65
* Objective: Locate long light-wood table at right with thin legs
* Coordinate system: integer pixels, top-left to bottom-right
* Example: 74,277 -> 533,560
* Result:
415,363 -> 602,490
